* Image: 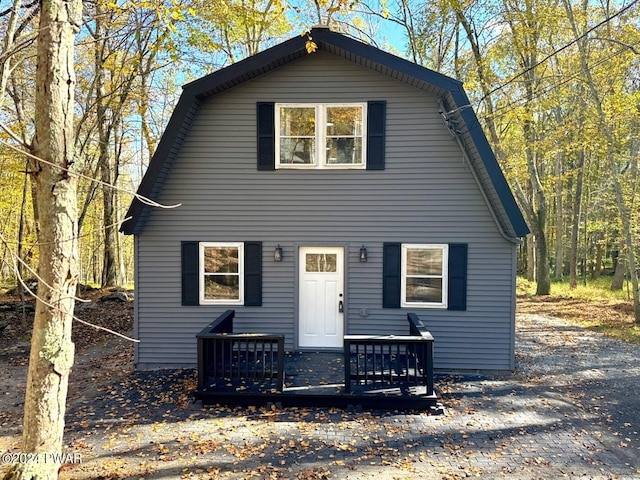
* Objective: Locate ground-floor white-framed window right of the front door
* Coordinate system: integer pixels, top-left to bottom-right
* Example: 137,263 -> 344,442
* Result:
401,244 -> 449,308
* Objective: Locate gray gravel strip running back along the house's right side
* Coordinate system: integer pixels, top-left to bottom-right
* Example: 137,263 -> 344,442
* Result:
516,315 -> 640,474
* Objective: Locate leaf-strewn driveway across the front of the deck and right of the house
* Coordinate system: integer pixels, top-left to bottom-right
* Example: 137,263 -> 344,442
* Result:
0,314 -> 640,480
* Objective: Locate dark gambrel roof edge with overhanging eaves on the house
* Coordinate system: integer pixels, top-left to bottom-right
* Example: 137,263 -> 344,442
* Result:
121,27 -> 529,239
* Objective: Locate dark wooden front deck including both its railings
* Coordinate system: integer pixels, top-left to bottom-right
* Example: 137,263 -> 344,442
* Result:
195,310 -> 438,411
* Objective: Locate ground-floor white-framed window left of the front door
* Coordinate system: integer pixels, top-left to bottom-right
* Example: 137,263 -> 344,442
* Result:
200,243 -> 242,303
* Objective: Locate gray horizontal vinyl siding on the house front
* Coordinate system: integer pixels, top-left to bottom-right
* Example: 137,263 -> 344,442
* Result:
136,52 -> 515,370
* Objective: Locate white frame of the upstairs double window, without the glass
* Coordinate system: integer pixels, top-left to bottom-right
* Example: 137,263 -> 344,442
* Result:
275,102 -> 367,170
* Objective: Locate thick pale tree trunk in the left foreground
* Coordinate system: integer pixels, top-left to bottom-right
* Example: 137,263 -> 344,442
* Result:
5,0 -> 82,480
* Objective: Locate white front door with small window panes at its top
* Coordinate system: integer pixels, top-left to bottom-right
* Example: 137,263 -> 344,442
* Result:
298,247 -> 344,348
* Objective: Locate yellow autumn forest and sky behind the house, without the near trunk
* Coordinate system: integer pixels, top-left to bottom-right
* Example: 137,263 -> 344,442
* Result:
0,0 -> 640,305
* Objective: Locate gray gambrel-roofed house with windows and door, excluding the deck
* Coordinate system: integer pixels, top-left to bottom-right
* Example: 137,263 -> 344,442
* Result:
122,28 -> 528,371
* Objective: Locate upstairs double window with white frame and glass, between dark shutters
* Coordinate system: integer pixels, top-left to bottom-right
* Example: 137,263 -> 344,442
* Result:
275,103 -> 367,168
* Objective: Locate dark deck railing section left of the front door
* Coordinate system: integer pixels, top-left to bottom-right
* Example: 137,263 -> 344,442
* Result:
196,310 -> 284,392
